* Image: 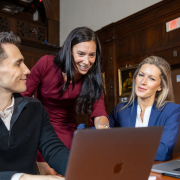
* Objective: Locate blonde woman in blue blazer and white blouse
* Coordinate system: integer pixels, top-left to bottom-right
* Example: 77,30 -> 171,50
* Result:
109,56 -> 180,161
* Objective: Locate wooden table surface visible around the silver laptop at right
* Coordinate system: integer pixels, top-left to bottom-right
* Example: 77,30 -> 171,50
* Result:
150,153 -> 180,180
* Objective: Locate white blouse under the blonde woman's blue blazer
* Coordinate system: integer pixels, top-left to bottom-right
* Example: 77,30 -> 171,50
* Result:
135,105 -> 152,127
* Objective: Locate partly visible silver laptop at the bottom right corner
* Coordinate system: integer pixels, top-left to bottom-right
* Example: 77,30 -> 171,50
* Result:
151,159 -> 180,178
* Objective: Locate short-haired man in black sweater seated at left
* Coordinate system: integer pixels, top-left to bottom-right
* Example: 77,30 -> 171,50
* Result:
0,32 -> 69,180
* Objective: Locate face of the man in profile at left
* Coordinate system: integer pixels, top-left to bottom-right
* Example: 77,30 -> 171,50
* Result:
0,43 -> 30,93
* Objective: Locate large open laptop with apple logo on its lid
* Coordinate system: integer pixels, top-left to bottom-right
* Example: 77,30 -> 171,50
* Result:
65,126 -> 163,180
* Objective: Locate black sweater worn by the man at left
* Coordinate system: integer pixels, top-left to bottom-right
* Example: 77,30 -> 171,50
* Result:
0,94 -> 69,180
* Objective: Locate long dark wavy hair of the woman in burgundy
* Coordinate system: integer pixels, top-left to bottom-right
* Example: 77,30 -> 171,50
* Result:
54,27 -> 104,114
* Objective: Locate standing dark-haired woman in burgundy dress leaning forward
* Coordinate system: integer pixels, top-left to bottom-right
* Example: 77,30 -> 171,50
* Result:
22,27 -> 109,174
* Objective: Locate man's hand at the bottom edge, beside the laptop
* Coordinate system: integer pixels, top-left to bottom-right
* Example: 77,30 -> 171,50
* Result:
19,174 -> 65,180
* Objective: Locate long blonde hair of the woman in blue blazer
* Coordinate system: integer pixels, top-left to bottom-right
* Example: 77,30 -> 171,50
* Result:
121,56 -> 174,110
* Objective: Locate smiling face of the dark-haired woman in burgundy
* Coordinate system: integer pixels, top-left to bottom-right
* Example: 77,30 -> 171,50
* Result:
72,40 -> 96,75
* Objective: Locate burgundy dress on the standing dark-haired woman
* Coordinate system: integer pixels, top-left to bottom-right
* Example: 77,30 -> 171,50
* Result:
22,55 -> 107,162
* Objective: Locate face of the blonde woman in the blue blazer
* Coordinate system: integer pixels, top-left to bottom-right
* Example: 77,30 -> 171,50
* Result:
135,64 -> 162,101
